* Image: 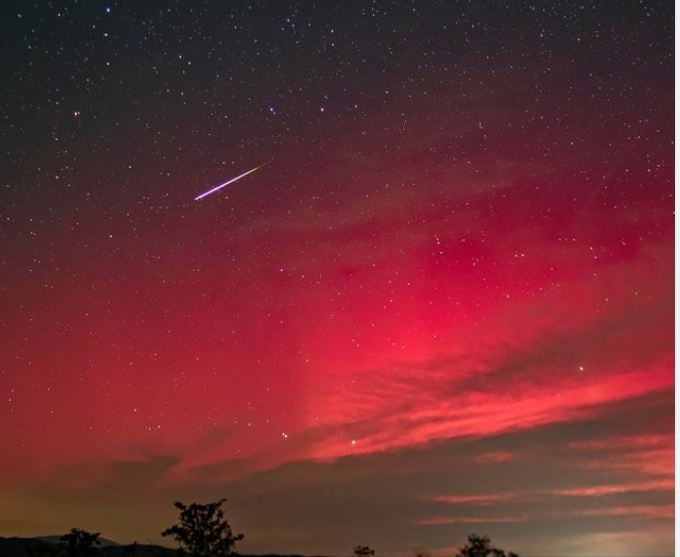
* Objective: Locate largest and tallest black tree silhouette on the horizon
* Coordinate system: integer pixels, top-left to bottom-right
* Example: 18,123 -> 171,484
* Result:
161,499 -> 243,557
